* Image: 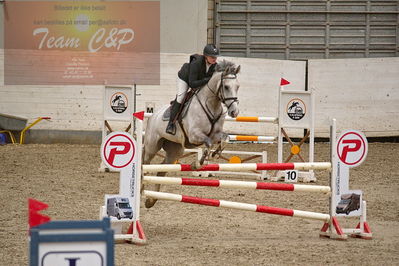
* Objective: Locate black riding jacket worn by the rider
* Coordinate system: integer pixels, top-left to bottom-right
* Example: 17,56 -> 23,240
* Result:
177,54 -> 216,89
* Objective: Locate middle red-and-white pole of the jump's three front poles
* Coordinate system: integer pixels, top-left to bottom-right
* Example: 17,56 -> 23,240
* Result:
143,176 -> 331,193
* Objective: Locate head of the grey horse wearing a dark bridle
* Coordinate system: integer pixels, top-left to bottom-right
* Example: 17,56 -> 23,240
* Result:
216,60 -> 240,117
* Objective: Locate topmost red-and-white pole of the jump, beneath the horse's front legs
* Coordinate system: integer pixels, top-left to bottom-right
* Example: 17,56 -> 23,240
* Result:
143,162 -> 331,172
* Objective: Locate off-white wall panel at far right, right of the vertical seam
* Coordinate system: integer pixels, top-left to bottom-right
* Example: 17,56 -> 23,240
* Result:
308,57 -> 399,137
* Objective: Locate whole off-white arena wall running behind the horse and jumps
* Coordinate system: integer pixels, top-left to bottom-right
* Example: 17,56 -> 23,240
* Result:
0,49 -> 399,142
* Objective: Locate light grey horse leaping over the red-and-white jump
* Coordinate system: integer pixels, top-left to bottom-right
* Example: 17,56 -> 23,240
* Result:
143,60 -> 240,208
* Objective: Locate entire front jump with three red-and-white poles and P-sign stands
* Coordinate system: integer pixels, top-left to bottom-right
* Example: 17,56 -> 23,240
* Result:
101,115 -> 372,244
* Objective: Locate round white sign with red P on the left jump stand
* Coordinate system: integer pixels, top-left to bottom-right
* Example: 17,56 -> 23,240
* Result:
101,132 -> 136,170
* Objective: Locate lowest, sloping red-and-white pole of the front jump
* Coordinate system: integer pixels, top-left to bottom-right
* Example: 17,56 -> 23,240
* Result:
144,190 -> 330,222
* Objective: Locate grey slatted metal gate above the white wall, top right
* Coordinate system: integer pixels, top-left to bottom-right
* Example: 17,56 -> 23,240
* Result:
214,0 -> 399,59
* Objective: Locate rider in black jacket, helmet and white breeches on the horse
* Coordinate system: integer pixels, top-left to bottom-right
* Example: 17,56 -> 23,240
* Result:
166,44 -> 219,135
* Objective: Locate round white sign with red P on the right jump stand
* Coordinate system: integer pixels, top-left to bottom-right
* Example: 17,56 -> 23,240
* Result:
337,130 -> 368,167
